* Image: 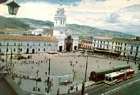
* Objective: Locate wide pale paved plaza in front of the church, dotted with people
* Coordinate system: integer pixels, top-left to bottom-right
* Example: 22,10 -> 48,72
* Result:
5,52 -> 137,95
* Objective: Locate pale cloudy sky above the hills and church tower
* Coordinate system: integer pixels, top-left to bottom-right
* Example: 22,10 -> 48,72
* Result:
0,0 -> 140,36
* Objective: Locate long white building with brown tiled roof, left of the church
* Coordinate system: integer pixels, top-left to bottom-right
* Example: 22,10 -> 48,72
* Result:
0,35 -> 58,54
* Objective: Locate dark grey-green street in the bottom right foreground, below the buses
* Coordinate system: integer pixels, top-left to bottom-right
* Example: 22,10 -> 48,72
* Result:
67,73 -> 140,95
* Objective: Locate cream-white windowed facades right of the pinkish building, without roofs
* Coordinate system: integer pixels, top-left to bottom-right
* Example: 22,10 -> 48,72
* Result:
92,39 -> 140,57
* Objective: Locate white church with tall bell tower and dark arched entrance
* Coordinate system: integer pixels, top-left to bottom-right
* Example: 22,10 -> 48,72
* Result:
53,8 -> 79,52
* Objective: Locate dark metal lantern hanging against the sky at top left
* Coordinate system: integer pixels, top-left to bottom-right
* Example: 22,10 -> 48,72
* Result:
7,0 -> 20,15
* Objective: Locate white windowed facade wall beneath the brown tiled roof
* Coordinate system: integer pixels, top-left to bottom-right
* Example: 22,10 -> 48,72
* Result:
0,40 -> 57,54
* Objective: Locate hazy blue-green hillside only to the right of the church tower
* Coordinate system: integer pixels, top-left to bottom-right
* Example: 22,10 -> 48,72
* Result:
67,24 -> 134,38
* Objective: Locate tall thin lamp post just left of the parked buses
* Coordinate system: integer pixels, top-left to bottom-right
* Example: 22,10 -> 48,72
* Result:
81,51 -> 88,95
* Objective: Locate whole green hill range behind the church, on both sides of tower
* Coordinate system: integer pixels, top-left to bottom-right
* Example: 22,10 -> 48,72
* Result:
0,16 -> 135,38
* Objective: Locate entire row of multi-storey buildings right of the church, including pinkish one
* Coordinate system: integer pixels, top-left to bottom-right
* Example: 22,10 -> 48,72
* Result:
79,37 -> 140,58
